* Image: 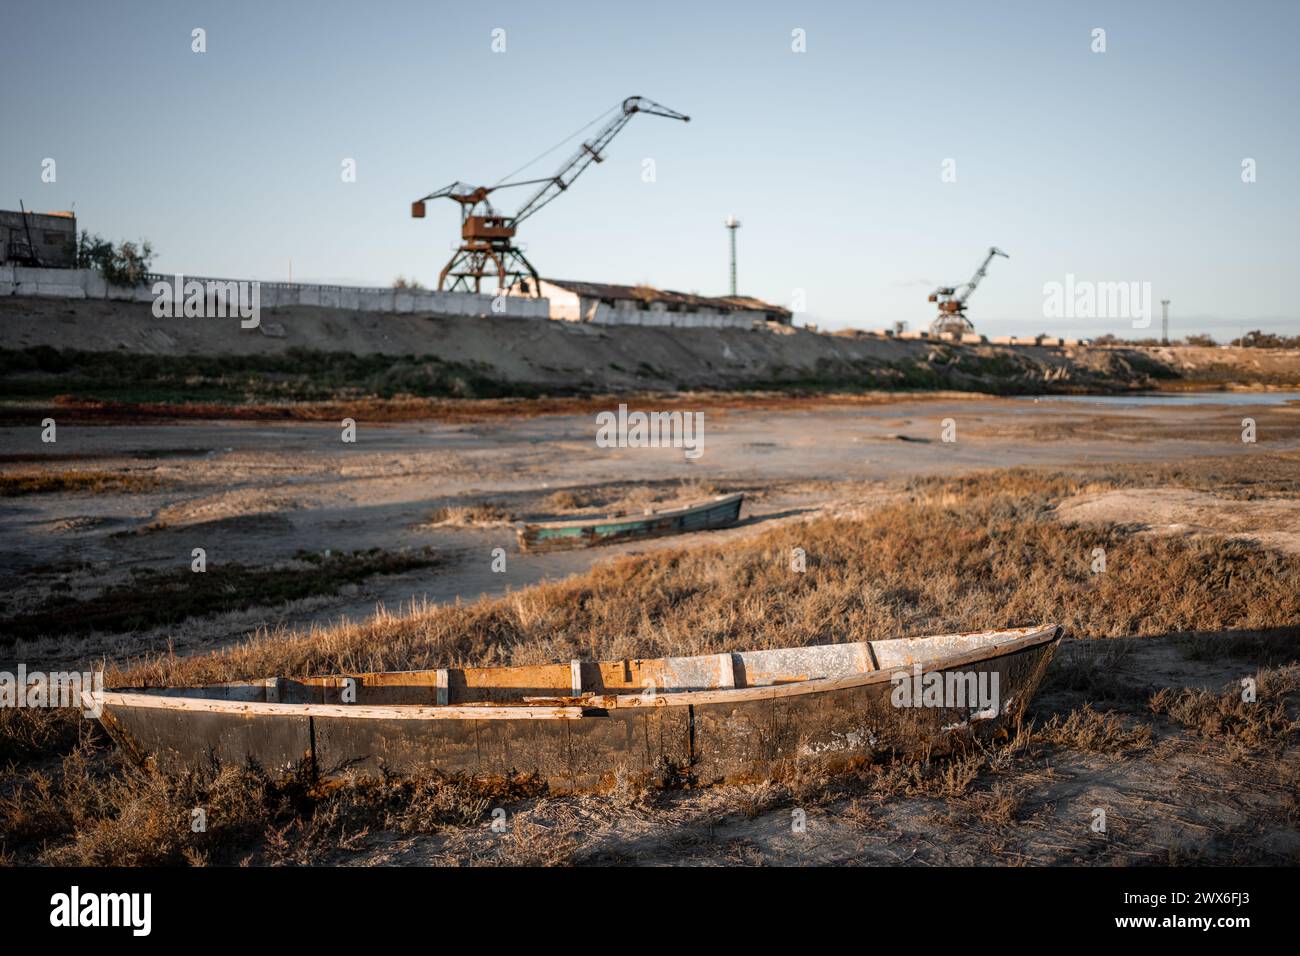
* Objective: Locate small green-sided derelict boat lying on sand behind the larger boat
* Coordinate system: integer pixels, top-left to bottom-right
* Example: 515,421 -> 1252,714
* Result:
516,494 -> 745,551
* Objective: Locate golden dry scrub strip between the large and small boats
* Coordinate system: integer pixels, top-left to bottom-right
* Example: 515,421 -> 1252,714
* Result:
89,472 -> 1300,683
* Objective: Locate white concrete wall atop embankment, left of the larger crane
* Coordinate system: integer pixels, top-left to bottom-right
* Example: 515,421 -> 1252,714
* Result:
0,265 -> 550,319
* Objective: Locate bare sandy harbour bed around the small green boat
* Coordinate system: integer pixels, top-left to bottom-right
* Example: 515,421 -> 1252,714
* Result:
0,398 -> 1300,659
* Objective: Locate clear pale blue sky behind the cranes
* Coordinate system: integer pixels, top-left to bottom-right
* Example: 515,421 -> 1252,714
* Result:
0,0 -> 1300,338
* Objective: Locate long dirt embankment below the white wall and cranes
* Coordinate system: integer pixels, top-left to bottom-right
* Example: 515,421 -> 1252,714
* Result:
0,298 -> 1300,401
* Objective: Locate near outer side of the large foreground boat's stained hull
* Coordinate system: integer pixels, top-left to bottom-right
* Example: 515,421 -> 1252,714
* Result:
94,627 -> 1062,792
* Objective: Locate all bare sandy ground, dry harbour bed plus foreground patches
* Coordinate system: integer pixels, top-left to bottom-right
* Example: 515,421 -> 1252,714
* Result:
0,398 -> 1300,865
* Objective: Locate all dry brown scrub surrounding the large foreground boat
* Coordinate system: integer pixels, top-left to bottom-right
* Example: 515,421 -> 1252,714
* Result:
0,468 -> 1300,865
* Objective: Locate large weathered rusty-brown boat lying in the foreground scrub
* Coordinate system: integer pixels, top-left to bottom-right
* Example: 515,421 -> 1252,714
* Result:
100,624 -> 1063,792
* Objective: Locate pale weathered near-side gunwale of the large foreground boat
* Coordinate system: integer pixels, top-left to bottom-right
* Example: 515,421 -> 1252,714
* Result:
94,624 -> 1065,721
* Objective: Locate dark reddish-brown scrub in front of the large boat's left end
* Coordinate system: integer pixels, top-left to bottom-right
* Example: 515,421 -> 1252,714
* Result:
0,736 -> 540,866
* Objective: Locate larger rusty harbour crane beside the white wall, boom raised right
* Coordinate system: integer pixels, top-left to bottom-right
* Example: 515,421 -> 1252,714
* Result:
411,96 -> 690,295
